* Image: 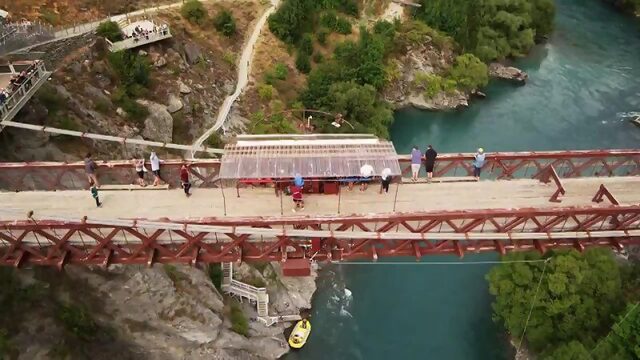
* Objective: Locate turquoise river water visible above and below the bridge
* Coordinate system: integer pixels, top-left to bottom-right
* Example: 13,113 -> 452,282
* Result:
287,0 -> 640,360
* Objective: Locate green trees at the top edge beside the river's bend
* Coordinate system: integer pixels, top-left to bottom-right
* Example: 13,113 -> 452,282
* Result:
416,0 -> 555,61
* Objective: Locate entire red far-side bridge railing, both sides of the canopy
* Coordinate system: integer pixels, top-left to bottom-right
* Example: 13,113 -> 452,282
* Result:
0,149 -> 640,191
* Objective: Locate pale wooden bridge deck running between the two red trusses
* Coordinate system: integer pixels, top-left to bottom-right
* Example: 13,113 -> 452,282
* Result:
0,177 -> 640,220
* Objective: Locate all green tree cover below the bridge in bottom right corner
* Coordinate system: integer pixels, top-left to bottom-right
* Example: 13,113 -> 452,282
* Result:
487,249 -> 640,360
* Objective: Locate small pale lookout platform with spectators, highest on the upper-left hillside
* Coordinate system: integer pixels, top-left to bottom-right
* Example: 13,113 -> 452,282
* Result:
105,19 -> 173,52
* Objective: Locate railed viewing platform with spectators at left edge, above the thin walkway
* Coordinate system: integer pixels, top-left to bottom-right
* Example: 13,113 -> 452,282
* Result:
0,60 -> 51,125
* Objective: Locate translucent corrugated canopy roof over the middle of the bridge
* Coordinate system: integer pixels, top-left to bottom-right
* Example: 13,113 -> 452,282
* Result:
220,134 -> 401,179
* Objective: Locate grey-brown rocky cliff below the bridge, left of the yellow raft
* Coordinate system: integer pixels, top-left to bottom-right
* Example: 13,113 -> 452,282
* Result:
12,264 -> 315,360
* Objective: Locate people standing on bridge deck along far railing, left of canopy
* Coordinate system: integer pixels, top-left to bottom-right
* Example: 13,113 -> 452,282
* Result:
84,151 -> 191,207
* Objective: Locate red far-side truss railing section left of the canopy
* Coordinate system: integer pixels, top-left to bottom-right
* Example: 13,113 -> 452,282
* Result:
0,160 -> 220,191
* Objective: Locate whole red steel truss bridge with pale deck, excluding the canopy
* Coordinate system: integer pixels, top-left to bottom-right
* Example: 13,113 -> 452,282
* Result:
0,150 -> 640,268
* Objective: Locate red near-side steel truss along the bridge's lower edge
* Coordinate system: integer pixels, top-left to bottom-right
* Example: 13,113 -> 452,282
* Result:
0,205 -> 640,268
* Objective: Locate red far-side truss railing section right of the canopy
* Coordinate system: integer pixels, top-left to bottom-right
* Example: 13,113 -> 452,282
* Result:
400,149 -> 640,180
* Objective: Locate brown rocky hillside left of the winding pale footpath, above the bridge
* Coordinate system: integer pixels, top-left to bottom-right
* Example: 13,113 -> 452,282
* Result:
2,0 -> 264,160
